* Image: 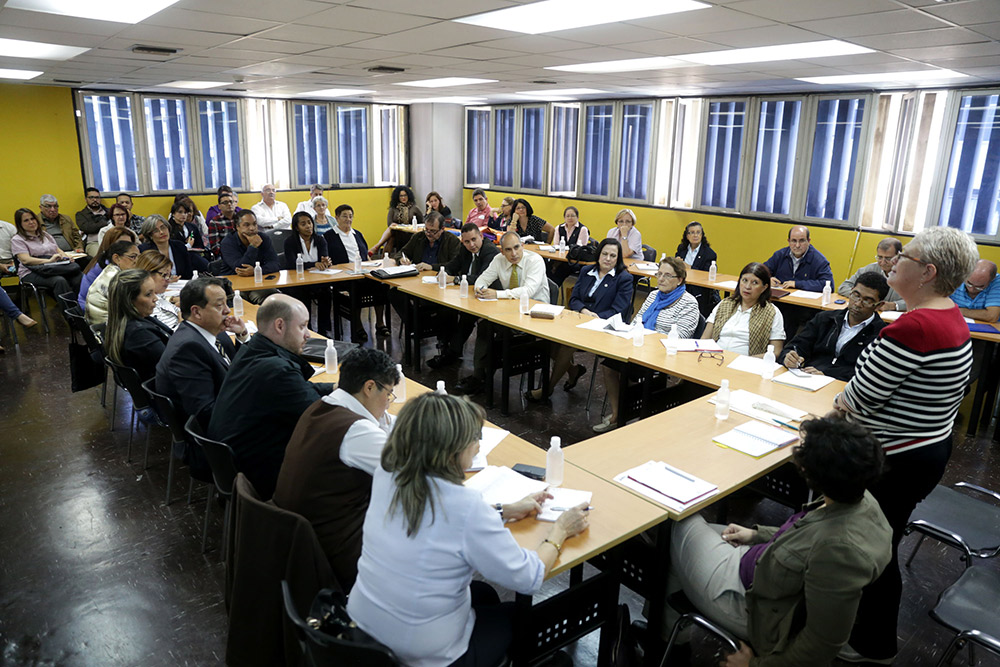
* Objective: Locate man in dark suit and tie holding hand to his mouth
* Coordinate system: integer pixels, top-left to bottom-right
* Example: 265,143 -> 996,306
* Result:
156,277 -> 249,428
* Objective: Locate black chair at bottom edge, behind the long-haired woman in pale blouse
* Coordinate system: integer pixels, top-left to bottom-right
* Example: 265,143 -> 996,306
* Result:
281,580 -> 400,667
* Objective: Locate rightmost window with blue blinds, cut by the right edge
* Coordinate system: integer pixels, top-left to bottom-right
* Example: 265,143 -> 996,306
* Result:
938,93 -> 1000,236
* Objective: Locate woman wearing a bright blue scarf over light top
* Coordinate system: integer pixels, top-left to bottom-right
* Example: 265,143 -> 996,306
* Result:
594,257 -> 699,433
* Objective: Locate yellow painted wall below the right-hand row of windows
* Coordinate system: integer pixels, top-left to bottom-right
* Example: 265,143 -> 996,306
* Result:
468,189 -> 1000,284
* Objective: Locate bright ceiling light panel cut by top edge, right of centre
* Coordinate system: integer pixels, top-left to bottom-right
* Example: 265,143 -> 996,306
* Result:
455,0 -> 711,35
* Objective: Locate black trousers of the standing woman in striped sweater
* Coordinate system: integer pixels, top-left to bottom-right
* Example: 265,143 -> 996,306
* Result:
849,435 -> 951,658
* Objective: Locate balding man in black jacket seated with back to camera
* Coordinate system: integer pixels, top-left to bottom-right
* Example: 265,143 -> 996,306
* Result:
208,294 -> 333,500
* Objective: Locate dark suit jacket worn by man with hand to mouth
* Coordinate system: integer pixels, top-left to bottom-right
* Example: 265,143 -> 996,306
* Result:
156,322 -> 236,428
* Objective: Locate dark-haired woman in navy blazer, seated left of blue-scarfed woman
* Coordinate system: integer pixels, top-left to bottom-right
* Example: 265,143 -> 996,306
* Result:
528,239 -> 633,401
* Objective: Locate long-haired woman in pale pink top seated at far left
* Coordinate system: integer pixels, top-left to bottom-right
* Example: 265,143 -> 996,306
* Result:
10,208 -> 83,295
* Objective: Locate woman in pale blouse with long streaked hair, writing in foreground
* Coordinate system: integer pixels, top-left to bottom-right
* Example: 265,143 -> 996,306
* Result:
347,394 -> 588,667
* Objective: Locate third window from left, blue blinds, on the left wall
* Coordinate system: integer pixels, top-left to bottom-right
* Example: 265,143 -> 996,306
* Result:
198,100 -> 243,190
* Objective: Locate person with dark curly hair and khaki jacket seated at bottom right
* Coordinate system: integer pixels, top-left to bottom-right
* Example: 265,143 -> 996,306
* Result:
663,418 -> 892,667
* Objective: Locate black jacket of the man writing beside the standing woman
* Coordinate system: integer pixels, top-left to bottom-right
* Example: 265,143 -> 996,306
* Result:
778,308 -> 887,382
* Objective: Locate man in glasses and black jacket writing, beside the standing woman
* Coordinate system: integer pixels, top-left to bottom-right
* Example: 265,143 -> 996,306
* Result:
778,272 -> 889,382
